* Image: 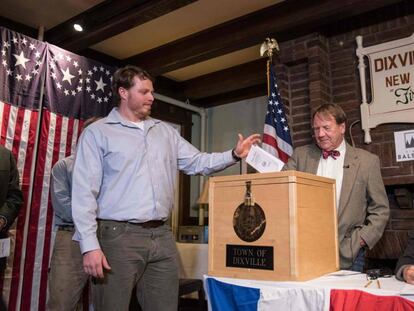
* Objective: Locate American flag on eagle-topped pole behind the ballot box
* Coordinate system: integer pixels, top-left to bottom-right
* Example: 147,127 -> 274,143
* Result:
262,62 -> 293,163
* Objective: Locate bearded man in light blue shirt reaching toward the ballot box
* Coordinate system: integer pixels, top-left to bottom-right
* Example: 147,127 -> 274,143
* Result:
72,66 -> 259,311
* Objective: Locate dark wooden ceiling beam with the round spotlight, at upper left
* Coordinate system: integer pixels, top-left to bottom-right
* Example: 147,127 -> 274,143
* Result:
45,0 -> 197,53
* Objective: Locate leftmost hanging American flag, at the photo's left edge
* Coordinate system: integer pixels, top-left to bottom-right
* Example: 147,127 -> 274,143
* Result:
0,28 -> 46,310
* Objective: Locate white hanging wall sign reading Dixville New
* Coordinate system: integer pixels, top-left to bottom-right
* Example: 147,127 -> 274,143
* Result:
356,34 -> 414,143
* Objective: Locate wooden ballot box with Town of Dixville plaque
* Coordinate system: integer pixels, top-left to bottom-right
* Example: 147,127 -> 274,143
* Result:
208,171 -> 339,281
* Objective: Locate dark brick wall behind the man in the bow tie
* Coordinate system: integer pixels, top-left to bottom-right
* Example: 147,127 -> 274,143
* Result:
276,12 -> 414,266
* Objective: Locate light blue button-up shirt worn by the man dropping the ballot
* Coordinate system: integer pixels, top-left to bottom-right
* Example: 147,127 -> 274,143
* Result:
72,108 -> 235,253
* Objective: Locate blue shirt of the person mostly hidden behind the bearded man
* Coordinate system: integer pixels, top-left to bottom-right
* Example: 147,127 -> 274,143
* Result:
50,155 -> 75,226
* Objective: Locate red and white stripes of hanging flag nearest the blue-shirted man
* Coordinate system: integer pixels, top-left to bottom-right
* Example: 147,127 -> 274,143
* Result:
20,110 -> 79,311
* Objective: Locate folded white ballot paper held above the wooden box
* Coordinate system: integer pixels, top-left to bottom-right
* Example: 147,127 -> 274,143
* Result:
246,145 -> 285,173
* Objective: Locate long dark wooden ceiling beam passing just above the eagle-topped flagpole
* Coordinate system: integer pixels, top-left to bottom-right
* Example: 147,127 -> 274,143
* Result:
125,0 -> 402,75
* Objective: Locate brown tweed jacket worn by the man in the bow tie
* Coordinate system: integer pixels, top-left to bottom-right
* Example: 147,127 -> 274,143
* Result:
284,144 -> 389,269
